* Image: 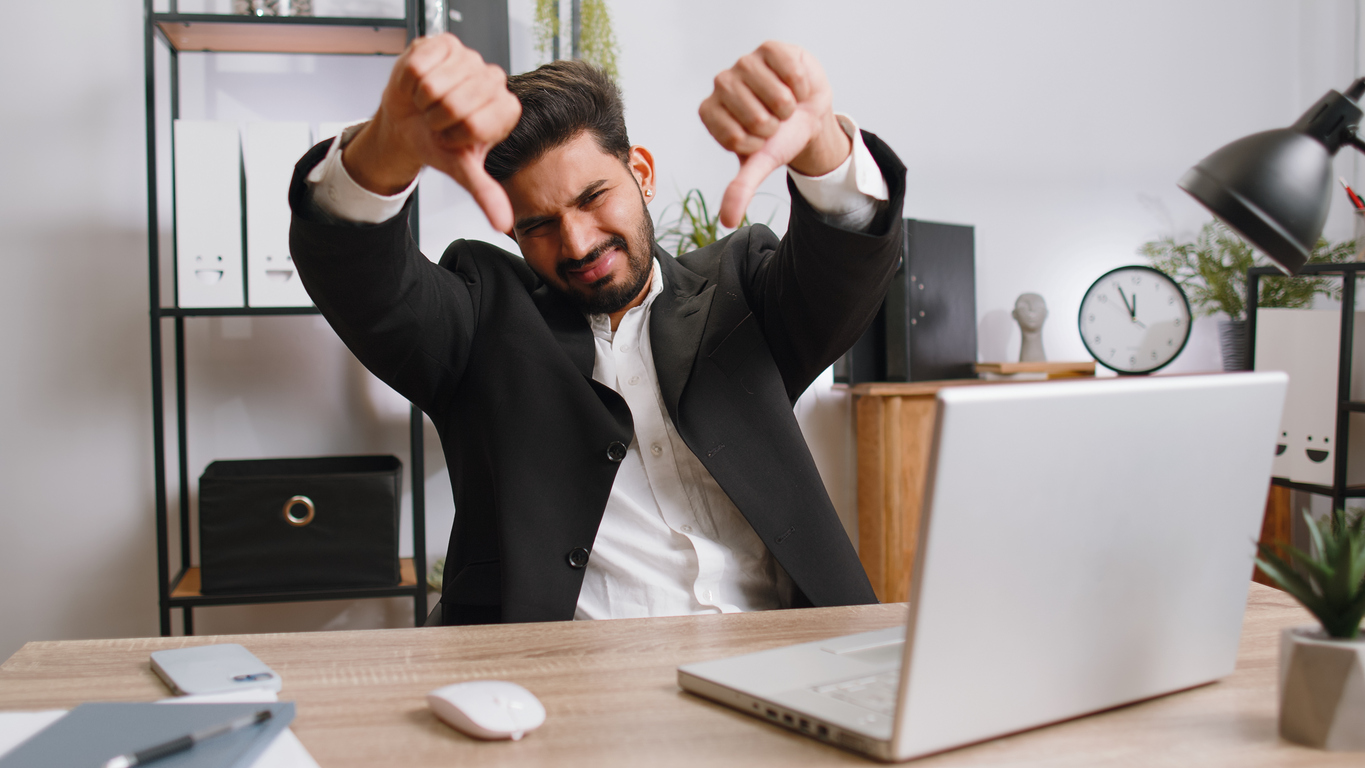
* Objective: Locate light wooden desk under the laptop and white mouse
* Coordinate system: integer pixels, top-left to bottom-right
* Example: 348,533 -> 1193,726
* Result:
0,584 -> 1343,768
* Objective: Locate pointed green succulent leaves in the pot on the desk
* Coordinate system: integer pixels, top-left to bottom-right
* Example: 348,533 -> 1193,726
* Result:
1256,509 -> 1365,640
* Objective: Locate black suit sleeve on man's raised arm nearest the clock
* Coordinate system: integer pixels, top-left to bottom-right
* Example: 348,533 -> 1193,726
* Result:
744,131 -> 905,402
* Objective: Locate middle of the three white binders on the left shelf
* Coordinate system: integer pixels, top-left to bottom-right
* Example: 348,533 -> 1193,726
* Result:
242,123 -> 313,307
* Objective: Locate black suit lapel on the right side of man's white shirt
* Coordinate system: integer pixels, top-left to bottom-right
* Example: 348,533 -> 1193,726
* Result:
650,244 -> 715,424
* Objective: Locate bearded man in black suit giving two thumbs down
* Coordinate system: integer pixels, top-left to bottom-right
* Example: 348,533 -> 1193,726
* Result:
289,35 -> 905,623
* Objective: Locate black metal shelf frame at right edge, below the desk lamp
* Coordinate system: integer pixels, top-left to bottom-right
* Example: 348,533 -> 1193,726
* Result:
1246,262 -> 1365,509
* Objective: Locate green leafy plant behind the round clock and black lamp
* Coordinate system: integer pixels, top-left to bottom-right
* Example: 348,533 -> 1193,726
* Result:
1137,221 -> 1355,321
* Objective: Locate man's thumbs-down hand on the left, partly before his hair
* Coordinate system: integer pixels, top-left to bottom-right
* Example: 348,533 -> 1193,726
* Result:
341,34 -> 521,232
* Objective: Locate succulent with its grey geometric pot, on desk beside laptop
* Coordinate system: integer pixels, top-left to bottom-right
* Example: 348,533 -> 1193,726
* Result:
1256,509 -> 1365,750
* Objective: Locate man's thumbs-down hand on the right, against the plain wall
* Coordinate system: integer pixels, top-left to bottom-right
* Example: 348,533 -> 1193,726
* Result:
698,41 -> 853,228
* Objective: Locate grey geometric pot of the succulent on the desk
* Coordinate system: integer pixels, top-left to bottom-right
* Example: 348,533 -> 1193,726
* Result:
1279,626 -> 1365,752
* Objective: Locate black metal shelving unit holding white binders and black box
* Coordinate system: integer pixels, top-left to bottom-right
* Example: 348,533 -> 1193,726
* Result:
143,0 -> 427,636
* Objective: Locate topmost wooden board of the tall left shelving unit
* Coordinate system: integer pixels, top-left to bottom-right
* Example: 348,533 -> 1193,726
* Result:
153,14 -> 408,56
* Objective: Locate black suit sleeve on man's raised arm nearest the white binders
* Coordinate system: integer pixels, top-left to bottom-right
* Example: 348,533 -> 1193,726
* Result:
289,142 -> 478,413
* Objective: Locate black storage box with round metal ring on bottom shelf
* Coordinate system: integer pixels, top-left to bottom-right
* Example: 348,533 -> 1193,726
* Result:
199,456 -> 403,595
